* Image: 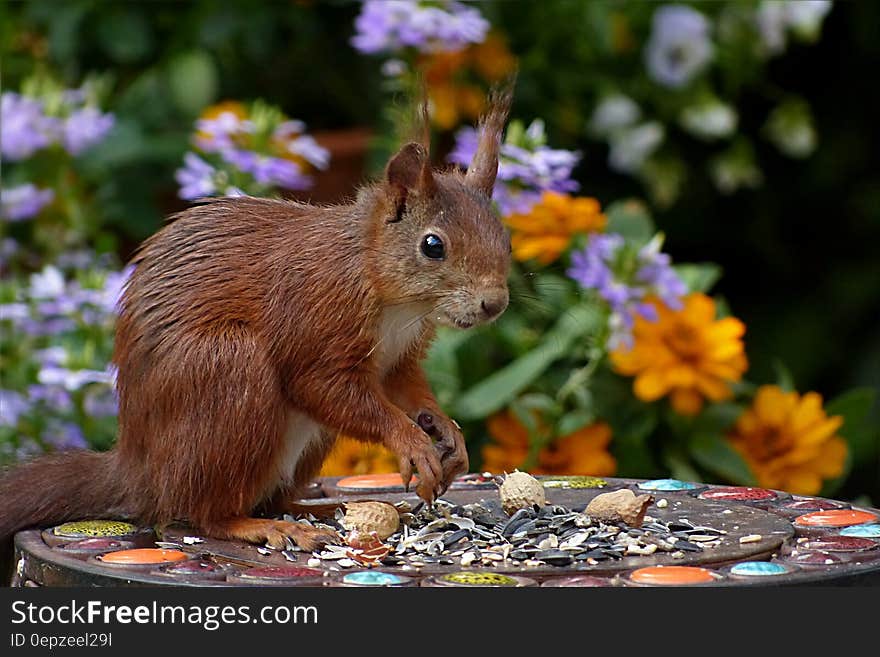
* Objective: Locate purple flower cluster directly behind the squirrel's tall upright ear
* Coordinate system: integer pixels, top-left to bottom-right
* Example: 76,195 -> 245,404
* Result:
448,120 -> 581,216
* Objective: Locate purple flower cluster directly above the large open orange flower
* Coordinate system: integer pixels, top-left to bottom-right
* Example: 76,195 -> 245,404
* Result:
566,234 -> 687,349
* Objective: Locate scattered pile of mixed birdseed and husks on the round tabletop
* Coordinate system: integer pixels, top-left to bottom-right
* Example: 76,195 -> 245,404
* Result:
291,499 -> 727,570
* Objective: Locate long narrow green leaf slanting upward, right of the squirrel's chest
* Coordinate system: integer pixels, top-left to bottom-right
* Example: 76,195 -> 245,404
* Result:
453,304 -> 599,421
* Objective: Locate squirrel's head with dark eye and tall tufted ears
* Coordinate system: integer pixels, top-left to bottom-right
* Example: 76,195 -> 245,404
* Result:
371,86 -> 511,328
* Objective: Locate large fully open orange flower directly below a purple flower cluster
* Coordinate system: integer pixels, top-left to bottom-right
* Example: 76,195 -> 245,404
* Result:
611,293 -> 748,415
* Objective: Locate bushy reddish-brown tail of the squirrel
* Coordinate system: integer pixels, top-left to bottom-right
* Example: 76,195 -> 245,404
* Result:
0,451 -> 130,544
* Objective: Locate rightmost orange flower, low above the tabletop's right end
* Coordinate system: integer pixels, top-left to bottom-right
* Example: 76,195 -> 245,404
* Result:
728,386 -> 847,495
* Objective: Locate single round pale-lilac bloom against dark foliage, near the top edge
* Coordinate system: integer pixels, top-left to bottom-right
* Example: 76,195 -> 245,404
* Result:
645,5 -> 713,88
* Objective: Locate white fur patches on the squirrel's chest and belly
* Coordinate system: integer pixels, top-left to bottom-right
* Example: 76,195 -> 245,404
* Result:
279,304 -> 427,481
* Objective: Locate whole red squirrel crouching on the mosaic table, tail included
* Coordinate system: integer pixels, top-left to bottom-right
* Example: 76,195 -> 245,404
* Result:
0,85 -> 512,550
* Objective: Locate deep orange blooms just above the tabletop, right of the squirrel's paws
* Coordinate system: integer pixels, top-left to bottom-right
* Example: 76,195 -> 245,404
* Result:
482,411 -> 617,476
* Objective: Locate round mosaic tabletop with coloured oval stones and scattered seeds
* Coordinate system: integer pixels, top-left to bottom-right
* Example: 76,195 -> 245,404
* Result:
12,474 -> 880,587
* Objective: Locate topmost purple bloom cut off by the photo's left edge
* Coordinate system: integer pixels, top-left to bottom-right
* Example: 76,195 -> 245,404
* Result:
0,91 -> 59,162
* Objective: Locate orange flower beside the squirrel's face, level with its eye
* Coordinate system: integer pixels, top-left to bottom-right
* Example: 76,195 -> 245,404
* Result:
504,191 -> 607,265
